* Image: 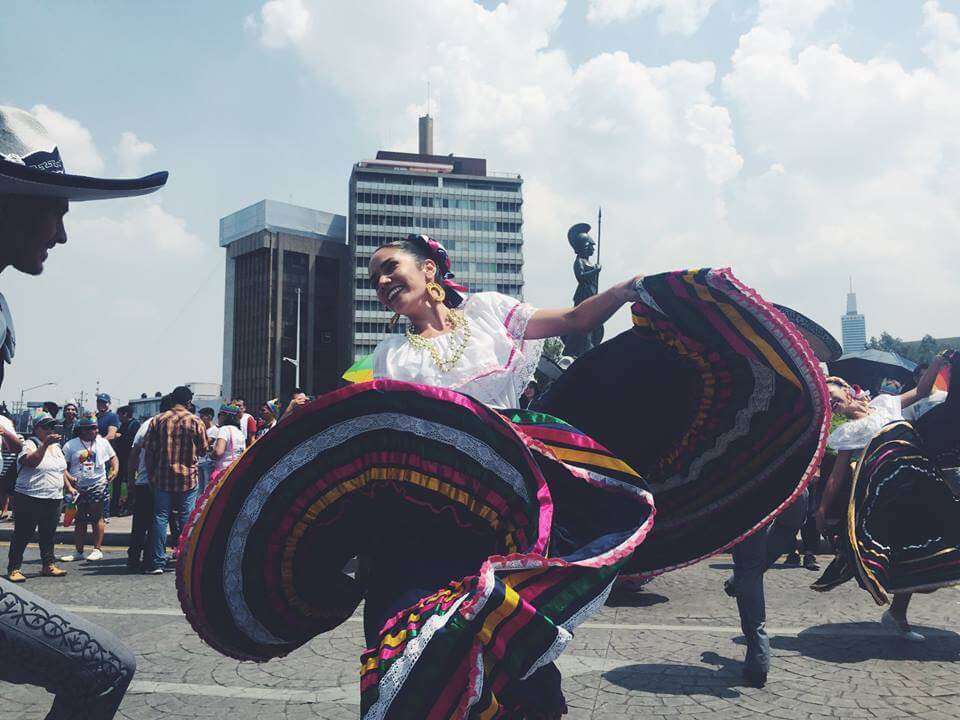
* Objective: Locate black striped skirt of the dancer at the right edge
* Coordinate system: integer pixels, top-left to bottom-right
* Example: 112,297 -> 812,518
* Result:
845,353 -> 960,605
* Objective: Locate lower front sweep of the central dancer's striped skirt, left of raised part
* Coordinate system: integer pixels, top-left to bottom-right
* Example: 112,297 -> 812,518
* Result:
177,380 -> 653,718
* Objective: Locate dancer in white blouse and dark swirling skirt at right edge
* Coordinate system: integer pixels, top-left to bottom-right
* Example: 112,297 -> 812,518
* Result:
811,352 -> 960,642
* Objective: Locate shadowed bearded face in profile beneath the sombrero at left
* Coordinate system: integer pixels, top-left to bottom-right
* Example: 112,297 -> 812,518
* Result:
0,196 -> 69,275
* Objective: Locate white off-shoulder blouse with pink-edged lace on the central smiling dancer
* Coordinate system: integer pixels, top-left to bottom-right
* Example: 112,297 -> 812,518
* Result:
373,292 -> 543,408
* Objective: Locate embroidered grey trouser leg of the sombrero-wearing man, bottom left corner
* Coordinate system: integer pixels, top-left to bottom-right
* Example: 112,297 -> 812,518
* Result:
0,578 -> 137,720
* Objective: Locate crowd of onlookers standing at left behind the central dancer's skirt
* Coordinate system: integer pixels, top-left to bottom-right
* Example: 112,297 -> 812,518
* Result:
0,386 -> 296,583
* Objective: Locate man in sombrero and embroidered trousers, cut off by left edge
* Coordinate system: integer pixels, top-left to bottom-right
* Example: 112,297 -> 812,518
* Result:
0,106 -> 167,720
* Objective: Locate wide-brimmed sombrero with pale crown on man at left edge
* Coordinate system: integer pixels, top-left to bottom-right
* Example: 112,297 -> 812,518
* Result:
0,106 -> 167,200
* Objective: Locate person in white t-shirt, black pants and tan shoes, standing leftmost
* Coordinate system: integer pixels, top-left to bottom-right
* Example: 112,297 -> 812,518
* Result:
7,413 -> 74,582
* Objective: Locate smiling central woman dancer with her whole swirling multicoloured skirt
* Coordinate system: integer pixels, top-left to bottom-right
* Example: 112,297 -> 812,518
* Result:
178,236 -> 826,718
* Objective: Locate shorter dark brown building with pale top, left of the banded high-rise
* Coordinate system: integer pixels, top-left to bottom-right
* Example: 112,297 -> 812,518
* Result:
220,200 -> 352,409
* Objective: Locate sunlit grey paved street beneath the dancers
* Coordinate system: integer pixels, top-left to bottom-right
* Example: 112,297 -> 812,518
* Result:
0,549 -> 960,720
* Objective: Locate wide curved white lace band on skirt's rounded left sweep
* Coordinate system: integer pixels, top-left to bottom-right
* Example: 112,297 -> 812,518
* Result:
223,413 -> 530,645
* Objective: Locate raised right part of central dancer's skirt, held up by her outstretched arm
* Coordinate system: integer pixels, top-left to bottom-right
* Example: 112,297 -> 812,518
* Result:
537,269 -> 829,577
